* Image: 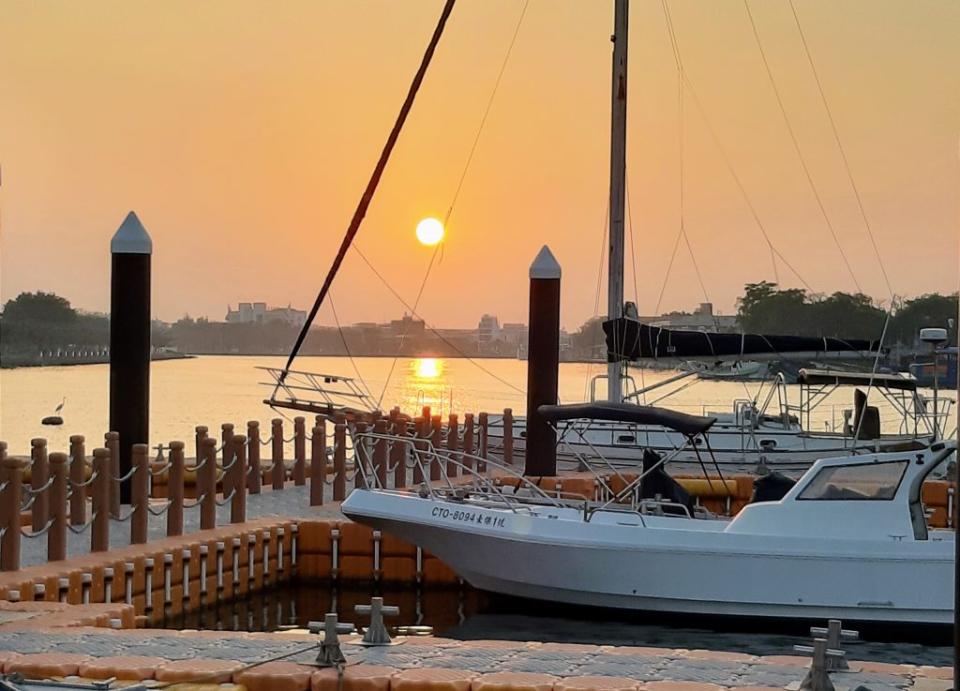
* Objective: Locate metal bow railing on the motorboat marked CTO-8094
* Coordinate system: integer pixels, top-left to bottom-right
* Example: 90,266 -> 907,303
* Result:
354,432 -> 579,511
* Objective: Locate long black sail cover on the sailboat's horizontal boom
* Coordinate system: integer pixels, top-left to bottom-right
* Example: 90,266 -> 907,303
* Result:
603,317 -> 880,362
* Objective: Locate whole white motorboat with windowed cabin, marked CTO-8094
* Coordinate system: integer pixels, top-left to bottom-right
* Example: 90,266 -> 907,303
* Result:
342,406 -> 956,624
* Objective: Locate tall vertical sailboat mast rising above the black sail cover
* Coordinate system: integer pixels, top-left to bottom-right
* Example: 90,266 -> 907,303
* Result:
607,0 -> 630,403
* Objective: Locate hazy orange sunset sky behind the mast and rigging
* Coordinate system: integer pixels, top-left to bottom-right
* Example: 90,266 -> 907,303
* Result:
0,0 -> 960,328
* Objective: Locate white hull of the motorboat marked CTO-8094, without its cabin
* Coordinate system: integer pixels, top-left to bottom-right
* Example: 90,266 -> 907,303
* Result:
343,491 -> 953,624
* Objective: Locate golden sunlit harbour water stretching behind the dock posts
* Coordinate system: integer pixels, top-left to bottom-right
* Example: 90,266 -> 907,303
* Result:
0,356 -> 928,454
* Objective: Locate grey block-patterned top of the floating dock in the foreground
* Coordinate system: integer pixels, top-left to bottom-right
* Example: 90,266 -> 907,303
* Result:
0,622 -> 940,691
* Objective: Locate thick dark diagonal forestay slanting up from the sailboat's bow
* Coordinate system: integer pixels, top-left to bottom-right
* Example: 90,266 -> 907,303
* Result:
277,0 -> 457,388
